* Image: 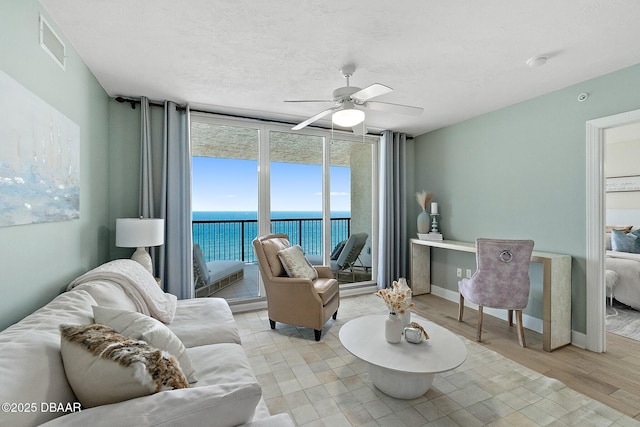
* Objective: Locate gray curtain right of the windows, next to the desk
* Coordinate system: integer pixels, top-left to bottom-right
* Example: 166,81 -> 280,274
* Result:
377,130 -> 409,289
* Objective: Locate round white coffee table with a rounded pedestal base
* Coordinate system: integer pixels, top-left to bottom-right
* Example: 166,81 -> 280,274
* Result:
340,314 -> 467,399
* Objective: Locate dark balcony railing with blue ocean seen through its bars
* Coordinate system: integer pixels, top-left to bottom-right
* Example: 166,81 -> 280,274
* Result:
192,218 -> 351,262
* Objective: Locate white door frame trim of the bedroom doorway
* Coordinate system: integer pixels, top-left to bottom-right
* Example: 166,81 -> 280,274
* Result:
585,110 -> 640,353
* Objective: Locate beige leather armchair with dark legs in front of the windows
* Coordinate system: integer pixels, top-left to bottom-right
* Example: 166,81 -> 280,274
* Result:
253,234 -> 340,341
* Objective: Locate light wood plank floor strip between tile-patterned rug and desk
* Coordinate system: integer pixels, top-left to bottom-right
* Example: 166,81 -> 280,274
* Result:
413,294 -> 640,421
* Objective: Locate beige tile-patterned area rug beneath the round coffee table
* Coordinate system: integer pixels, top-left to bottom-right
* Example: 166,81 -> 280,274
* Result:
234,295 -> 640,427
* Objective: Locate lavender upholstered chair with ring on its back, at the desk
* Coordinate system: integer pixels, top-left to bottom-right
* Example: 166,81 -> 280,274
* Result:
458,239 -> 533,347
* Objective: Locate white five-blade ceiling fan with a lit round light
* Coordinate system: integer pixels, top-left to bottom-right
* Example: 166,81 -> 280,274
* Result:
285,64 -> 423,135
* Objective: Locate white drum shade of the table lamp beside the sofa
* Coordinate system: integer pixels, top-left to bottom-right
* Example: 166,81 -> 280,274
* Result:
116,218 -> 164,248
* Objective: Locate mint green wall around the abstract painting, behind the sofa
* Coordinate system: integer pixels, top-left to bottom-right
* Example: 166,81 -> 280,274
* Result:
0,0 -> 110,329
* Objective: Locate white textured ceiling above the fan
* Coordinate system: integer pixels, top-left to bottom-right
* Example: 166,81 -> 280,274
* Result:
41,0 -> 640,135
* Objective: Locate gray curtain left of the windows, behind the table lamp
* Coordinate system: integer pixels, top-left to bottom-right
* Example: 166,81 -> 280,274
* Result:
140,98 -> 194,299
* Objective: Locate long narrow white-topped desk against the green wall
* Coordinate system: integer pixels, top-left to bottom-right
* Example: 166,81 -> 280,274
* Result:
409,239 -> 571,351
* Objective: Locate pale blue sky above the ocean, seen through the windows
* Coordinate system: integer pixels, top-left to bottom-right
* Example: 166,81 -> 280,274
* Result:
192,157 -> 351,211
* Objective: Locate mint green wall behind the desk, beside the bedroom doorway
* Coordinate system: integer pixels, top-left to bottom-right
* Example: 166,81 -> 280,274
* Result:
408,65 -> 640,333
